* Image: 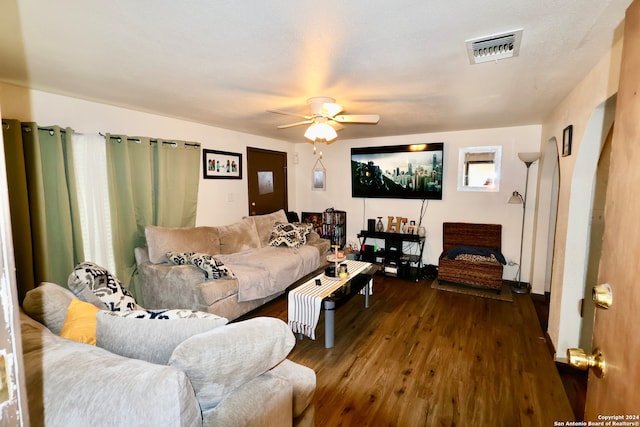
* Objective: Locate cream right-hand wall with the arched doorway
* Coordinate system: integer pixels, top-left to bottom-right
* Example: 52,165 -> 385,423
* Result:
542,35 -> 622,359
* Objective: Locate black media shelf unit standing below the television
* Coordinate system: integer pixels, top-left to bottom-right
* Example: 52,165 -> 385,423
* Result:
358,230 -> 425,282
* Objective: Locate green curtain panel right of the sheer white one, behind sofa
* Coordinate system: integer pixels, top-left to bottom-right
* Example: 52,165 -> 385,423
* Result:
106,134 -> 200,300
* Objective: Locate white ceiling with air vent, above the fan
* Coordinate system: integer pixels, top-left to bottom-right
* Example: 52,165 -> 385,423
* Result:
0,0 -> 631,142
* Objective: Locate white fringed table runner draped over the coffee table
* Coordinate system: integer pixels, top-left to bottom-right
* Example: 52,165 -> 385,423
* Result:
288,260 -> 373,340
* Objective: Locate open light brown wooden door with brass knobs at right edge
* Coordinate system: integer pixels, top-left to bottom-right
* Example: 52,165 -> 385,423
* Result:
585,0 -> 640,425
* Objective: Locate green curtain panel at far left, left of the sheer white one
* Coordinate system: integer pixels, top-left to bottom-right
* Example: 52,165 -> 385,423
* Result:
3,120 -> 83,298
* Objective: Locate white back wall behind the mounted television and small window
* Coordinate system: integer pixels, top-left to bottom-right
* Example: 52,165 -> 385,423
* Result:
296,125 -> 544,285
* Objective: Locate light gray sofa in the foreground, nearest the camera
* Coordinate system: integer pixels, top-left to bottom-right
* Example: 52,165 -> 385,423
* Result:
20,283 -> 316,427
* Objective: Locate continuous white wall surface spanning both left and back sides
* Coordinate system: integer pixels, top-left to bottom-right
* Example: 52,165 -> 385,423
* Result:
0,84 -> 543,287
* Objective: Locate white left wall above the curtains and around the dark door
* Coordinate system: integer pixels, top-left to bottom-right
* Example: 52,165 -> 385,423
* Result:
0,84 -> 296,229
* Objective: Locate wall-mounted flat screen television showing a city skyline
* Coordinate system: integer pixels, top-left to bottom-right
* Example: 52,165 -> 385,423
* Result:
351,142 -> 444,200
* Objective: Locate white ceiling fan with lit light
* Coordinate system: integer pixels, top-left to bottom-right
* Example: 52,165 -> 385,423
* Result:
267,96 -> 380,143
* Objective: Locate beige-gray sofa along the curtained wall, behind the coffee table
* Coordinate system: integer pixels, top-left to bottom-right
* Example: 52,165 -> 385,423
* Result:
135,210 -> 330,320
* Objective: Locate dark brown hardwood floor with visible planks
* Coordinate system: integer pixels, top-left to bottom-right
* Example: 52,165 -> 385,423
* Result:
242,275 -> 575,427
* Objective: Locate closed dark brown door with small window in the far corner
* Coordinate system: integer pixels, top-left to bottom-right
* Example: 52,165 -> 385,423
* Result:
247,147 -> 288,215
